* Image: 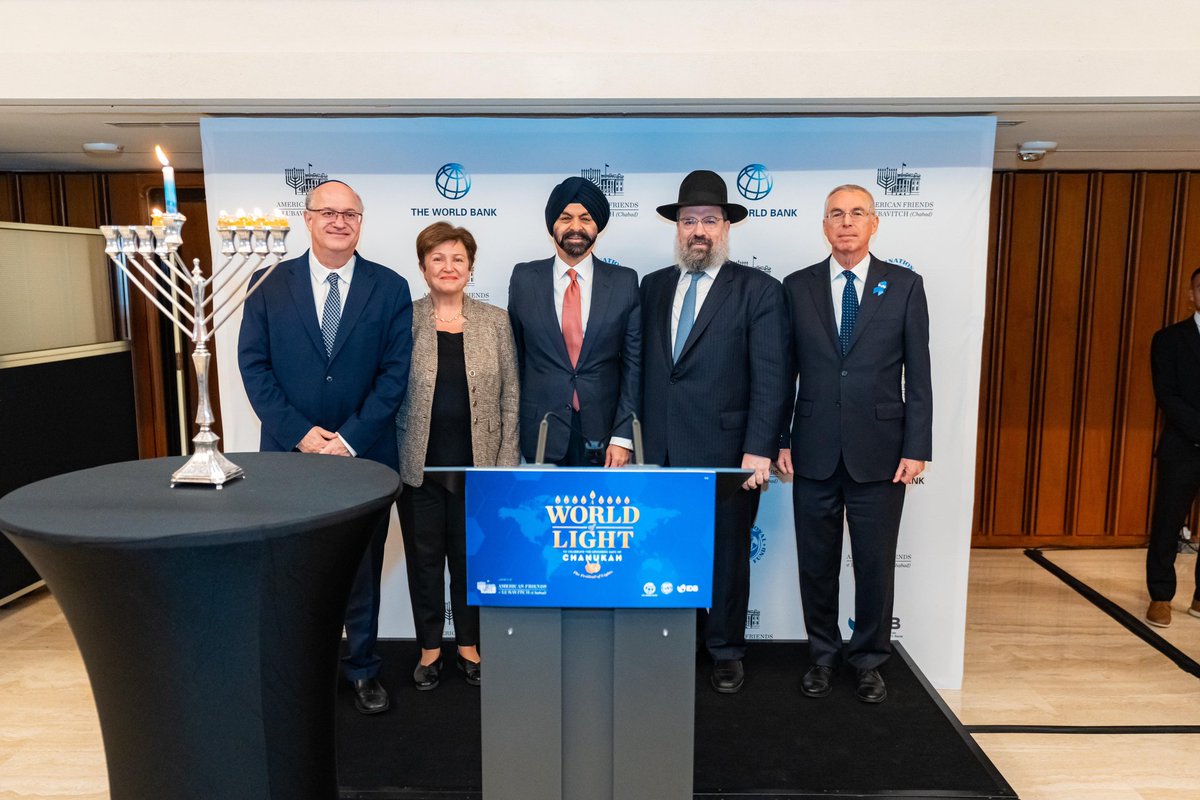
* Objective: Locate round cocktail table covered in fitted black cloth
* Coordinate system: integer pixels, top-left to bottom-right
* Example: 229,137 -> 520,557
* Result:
0,453 -> 400,800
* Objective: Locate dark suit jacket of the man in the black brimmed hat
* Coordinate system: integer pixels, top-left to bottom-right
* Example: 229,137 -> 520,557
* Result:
642,261 -> 791,467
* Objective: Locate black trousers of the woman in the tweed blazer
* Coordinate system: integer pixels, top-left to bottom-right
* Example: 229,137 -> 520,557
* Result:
397,475 -> 479,650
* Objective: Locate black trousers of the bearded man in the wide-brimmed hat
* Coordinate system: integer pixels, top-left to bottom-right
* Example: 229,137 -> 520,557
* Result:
700,489 -> 761,660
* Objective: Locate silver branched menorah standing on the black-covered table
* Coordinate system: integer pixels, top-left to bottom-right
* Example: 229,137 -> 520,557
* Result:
100,205 -> 288,489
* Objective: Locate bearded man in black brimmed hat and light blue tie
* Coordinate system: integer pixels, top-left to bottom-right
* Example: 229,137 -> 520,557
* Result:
642,170 -> 790,693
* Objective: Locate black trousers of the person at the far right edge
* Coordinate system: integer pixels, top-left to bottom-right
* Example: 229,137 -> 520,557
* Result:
1146,459 -> 1200,601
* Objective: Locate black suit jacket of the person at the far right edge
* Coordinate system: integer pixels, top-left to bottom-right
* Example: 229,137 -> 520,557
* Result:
1150,317 -> 1200,461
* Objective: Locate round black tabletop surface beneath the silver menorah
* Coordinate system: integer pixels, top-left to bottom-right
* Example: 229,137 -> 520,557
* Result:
0,453 -> 400,546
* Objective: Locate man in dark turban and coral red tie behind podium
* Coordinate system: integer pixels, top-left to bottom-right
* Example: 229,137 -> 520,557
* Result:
509,178 -> 642,467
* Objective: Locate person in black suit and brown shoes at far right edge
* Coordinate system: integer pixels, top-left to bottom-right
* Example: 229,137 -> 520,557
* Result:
1146,269 -> 1200,627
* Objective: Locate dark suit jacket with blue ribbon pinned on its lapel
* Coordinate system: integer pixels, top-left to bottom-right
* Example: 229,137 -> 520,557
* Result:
784,255 -> 934,482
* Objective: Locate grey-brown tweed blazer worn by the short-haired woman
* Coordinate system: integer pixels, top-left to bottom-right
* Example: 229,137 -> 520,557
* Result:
396,296 -> 521,486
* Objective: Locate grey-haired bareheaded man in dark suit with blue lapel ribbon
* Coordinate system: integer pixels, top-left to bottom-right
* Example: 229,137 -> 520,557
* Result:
779,185 -> 934,703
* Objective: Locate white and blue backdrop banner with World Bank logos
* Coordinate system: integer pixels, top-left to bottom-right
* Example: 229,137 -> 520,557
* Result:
199,116 -> 995,688
